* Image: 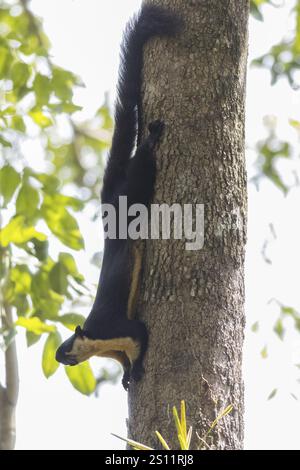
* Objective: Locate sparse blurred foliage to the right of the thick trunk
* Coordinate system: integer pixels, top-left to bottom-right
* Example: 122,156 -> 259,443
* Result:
251,0 -> 300,386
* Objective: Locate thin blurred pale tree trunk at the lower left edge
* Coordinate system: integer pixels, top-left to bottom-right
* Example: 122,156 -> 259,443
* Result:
0,304 -> 19,450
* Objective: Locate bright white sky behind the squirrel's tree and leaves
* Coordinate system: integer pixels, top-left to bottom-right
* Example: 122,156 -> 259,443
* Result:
12,0 -> 300,449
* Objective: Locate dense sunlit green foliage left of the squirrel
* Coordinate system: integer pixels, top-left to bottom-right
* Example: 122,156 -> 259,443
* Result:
0,0 -> 112,394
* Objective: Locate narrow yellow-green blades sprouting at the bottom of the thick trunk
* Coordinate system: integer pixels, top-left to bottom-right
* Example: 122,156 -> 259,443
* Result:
112,400 -> 233,450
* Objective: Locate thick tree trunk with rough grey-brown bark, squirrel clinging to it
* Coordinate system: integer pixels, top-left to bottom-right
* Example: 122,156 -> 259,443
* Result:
128,0 -> 249,449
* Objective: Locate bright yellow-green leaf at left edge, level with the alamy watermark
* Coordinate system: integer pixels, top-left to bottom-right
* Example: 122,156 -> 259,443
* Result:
0,215 -> 47,247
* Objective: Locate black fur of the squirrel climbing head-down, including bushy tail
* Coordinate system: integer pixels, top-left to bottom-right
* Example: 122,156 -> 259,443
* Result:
56,5 -> 180,390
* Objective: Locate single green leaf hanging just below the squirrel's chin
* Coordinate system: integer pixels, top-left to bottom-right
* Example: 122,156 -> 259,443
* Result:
65,361 -> 96,395
